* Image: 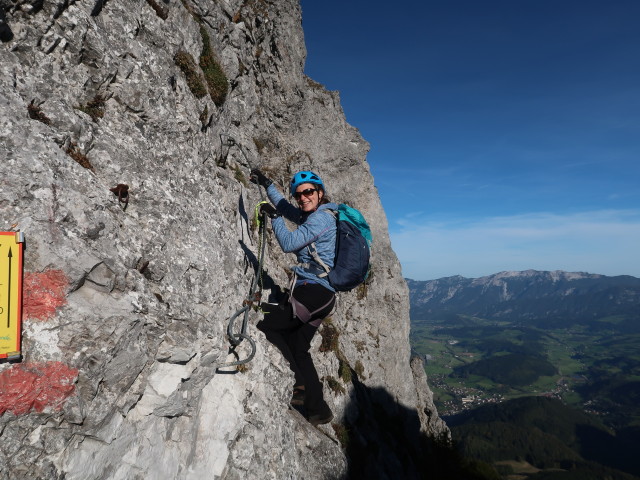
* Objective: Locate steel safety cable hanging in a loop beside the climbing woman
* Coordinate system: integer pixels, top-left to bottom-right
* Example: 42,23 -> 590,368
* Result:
216,135 -> 268,369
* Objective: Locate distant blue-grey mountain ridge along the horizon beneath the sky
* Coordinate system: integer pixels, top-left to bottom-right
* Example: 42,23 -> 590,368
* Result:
406,270 -> 640,323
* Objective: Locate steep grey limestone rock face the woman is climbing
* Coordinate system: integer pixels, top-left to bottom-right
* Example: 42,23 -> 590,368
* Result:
0,0 -> 448,480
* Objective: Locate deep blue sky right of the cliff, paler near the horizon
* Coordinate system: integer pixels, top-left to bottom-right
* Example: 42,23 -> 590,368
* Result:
302,0 -> 640,280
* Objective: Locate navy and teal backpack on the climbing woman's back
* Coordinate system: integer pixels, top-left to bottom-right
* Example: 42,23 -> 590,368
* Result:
309,203 -> 373,292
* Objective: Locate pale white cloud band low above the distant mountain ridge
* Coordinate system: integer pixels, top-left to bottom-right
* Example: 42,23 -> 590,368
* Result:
391,210 -> 640,280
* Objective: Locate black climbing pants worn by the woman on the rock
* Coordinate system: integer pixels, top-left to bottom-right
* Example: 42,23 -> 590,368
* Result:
257,283 -> 335,415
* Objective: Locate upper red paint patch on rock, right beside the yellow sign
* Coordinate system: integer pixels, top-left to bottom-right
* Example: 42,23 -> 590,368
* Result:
22,270 -> 69,321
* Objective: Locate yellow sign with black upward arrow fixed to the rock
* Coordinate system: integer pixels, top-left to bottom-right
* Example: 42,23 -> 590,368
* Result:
0,232 -> 24,360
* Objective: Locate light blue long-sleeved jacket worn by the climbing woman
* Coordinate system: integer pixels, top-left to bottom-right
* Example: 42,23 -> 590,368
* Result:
267,183 -> 338,292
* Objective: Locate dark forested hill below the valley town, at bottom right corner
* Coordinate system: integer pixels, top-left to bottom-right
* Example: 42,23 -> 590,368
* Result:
447,397 -> 640,480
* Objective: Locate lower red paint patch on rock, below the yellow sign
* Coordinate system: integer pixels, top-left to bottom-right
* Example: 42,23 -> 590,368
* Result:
0,362 -> 78,415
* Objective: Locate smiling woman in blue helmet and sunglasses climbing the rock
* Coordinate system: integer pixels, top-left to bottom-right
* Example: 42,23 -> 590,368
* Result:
251,169 -> 338,425
